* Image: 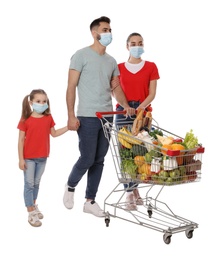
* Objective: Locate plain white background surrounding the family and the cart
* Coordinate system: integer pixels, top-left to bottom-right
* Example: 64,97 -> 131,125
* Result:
0,0 -> 224,260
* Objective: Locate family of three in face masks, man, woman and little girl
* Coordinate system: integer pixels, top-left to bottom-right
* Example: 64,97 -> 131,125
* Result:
18,16 -> 159,227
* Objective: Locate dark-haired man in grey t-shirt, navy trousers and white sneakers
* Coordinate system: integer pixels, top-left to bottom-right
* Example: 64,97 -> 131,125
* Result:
63,16 -> 135,217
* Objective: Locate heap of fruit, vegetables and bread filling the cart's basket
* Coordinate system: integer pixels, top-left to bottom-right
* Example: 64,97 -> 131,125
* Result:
117,109 -> 204,185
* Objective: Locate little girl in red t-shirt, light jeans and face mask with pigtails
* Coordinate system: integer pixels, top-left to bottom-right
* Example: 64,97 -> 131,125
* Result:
17,89 -> 68,227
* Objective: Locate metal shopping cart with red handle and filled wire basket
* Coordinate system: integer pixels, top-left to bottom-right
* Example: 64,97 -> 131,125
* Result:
96,111 -> 204,244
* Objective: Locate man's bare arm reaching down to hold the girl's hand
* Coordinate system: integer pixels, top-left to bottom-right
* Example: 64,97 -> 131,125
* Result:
66,69 -> 80,130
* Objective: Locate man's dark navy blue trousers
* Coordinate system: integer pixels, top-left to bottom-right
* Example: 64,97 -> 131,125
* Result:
67,117 -> 113,200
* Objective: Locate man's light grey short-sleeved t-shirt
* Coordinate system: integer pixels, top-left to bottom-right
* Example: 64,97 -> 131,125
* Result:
69,47 -> 119,117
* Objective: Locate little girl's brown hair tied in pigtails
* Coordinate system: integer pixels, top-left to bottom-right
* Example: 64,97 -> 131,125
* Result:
21,89 -> 51,120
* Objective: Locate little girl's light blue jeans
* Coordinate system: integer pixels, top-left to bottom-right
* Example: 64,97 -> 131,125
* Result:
24,158 -> 47,207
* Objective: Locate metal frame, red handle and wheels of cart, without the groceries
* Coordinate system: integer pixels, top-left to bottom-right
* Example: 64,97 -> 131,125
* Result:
96,111 -> 204,244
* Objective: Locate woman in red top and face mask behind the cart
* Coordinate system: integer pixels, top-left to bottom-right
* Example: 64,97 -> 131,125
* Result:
112,33 -> 160,210
